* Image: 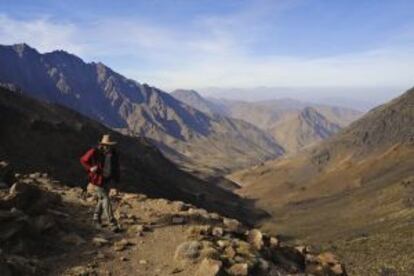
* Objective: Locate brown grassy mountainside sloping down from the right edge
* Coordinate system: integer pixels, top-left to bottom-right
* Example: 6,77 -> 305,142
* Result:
231,89 -> 414,275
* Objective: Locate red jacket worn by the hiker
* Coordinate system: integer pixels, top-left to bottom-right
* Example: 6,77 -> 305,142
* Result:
80,148 -> 120,186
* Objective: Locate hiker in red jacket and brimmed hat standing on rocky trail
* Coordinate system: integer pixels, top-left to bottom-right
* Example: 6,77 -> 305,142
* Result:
80,134 -> 120,231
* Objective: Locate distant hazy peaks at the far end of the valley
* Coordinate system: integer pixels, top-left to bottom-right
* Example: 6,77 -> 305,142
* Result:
171,90 -> 361,153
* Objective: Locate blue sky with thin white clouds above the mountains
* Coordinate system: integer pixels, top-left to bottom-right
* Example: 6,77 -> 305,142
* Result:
0,0 -> 414,99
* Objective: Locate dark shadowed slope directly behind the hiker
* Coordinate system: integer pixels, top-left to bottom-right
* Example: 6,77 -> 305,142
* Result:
0,88 -> 265,223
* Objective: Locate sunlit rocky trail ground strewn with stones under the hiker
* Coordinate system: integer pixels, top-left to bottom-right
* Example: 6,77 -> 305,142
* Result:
0,163 -> 346,276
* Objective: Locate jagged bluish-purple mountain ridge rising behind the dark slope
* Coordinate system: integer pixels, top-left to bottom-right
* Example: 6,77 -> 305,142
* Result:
0,44 -> 283,175
